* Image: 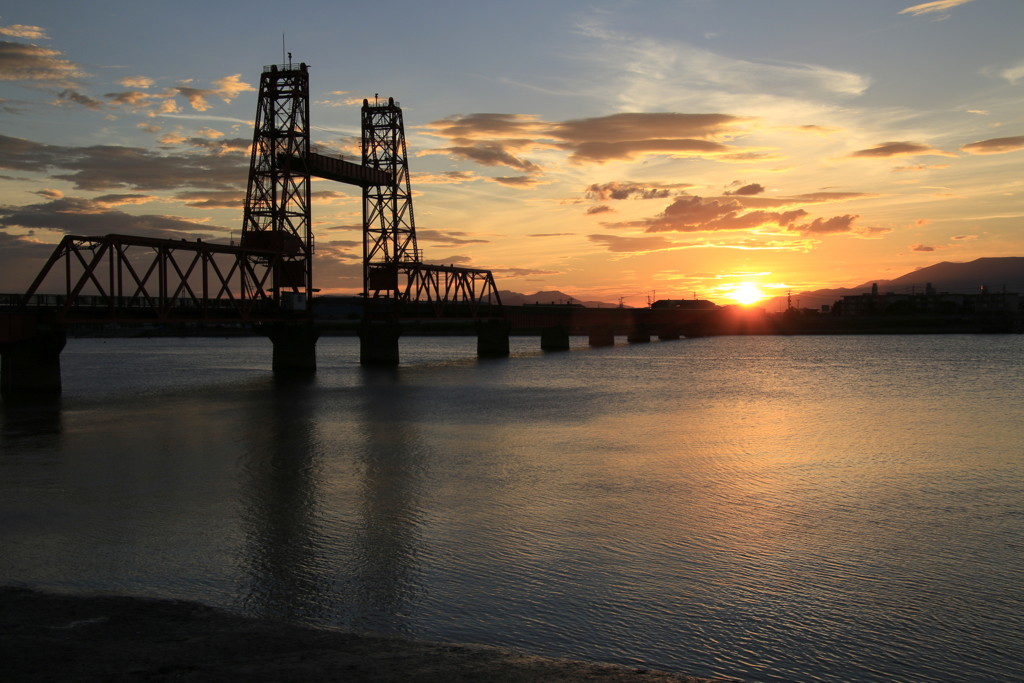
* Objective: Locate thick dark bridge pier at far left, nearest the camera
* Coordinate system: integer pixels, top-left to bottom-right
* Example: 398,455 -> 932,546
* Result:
0,328 -> 68,397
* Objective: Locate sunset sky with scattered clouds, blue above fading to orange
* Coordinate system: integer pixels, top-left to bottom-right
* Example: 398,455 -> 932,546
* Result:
0,0 -> 1024,305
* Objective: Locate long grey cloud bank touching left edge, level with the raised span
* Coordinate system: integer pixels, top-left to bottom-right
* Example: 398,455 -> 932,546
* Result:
0,135 -> 249,191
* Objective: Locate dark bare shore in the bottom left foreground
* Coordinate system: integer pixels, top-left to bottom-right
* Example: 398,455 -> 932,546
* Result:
0,586 -> 724,683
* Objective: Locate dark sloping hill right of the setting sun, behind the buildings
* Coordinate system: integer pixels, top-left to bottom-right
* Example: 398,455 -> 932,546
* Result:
762,256 -> 1024,311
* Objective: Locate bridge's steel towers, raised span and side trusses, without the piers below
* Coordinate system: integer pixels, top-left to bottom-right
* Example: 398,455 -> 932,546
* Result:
7,63 -> 501,331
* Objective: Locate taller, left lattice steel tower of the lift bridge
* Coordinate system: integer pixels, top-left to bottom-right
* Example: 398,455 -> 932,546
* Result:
242,63 -> 313,310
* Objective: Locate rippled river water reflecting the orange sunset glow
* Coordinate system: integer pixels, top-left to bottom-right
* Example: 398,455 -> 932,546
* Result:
0,335 -> 1024,681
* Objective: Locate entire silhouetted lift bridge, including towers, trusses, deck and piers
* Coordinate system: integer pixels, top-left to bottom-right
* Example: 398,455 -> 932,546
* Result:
0,63 -> 712,401
